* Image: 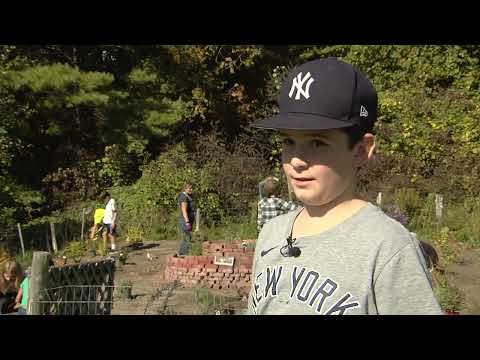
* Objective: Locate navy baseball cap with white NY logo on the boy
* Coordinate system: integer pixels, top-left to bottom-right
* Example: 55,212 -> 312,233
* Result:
252,57 -> 377,130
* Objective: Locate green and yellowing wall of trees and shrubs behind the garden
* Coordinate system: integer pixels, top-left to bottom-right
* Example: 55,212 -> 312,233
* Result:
0,45 -> 480,258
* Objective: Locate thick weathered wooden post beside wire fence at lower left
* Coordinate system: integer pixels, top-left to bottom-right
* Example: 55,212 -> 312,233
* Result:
27,251 -> 50,315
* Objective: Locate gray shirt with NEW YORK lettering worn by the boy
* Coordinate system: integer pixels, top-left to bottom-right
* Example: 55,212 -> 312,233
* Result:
247,203 -> 442,315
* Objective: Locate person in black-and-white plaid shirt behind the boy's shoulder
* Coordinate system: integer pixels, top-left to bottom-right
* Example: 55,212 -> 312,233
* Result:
257,177 -> 298,233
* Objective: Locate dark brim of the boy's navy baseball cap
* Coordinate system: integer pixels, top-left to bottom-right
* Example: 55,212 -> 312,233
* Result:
251,113 -> 354,130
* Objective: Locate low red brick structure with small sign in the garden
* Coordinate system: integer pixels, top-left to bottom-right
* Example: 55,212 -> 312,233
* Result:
165,240 -> 255,290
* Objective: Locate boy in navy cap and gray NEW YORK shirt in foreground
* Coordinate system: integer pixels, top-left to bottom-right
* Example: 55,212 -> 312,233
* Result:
247,58 -> 442,315
